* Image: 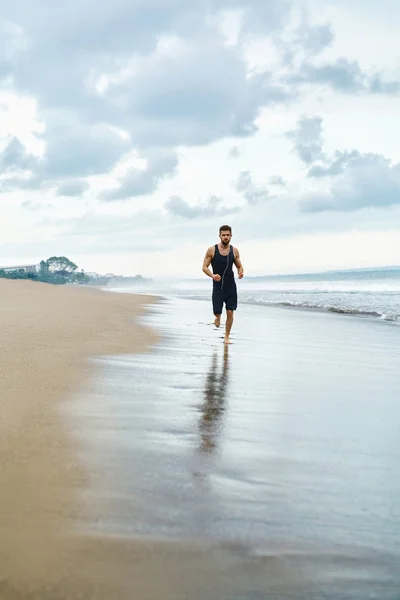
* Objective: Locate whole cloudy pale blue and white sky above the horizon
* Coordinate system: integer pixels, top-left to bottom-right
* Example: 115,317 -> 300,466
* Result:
0,0 -> 400,277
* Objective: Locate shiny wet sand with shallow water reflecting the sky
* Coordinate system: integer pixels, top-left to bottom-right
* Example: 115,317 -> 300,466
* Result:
74,300 -> 400,600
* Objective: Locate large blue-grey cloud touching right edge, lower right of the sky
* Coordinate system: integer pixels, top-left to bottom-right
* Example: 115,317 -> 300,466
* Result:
300,153 -> 400,213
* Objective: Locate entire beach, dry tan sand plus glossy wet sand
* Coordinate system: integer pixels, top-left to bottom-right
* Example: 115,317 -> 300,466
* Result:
0,281 -> 400,600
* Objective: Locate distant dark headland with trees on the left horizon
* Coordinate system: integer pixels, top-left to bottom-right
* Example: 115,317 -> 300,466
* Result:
0,256 -> 150,286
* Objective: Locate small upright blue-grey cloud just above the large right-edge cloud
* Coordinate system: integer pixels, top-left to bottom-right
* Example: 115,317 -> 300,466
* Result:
286,116 -> 323,165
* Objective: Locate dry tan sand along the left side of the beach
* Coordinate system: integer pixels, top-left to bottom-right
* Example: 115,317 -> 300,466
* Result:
0,280 -> 158,600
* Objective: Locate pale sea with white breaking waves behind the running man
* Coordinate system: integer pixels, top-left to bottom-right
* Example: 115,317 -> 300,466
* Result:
108,267 -> 400,324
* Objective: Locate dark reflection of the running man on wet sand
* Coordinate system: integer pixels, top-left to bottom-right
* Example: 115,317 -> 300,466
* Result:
199,346 -> 228,453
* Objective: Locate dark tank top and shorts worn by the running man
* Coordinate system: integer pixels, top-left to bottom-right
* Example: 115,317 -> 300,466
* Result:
211,244 -> 237,315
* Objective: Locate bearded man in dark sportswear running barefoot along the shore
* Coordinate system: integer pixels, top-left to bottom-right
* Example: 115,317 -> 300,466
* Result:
203,225 -> 243,344
